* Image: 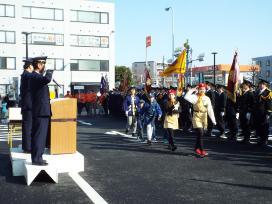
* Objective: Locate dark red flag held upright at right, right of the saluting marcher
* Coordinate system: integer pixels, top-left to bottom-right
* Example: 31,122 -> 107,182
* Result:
227,52 -> 240,103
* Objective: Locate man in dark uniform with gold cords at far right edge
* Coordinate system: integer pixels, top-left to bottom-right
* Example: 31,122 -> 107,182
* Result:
253,79 -> 272,145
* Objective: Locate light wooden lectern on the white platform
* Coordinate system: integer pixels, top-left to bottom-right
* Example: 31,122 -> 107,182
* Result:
50,98 -> 77,154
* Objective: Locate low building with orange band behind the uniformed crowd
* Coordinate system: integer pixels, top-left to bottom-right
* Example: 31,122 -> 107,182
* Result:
188,64 -> 259,85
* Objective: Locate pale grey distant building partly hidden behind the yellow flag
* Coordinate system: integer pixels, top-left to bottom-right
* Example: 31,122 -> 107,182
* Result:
132,61 -> 176,87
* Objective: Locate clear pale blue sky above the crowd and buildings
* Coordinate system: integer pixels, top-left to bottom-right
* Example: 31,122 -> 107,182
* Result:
96,0 -> 272,67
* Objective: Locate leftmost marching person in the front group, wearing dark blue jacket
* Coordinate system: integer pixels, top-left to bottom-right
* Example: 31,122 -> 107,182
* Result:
123,87 -> 140,137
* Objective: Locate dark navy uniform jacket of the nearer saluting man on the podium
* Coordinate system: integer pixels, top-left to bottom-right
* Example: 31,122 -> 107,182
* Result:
31,71 -> 52,117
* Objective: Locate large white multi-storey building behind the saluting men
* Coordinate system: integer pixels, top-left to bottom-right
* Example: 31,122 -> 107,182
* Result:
0,0 -> 115,99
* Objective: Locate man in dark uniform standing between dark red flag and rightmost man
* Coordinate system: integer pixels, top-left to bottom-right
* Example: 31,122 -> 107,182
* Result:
239,80 -> 255,143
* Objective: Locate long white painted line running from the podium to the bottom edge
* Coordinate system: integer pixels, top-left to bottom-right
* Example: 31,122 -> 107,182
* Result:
69,173 -> 107,204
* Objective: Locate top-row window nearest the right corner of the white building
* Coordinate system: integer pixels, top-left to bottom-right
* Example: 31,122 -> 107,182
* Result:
70,10 -> 109,24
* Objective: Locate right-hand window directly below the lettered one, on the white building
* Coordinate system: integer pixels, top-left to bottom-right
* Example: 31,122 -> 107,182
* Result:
70,59 -> 109,71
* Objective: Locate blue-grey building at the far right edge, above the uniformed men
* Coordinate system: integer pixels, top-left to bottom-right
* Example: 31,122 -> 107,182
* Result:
252,55 -> 272,83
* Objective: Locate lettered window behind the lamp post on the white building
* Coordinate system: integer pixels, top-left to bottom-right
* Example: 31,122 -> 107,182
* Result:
23,33 -> 64,46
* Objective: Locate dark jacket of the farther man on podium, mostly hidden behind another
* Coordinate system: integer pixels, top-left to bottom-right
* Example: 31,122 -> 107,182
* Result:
20,71 -> 32,111
